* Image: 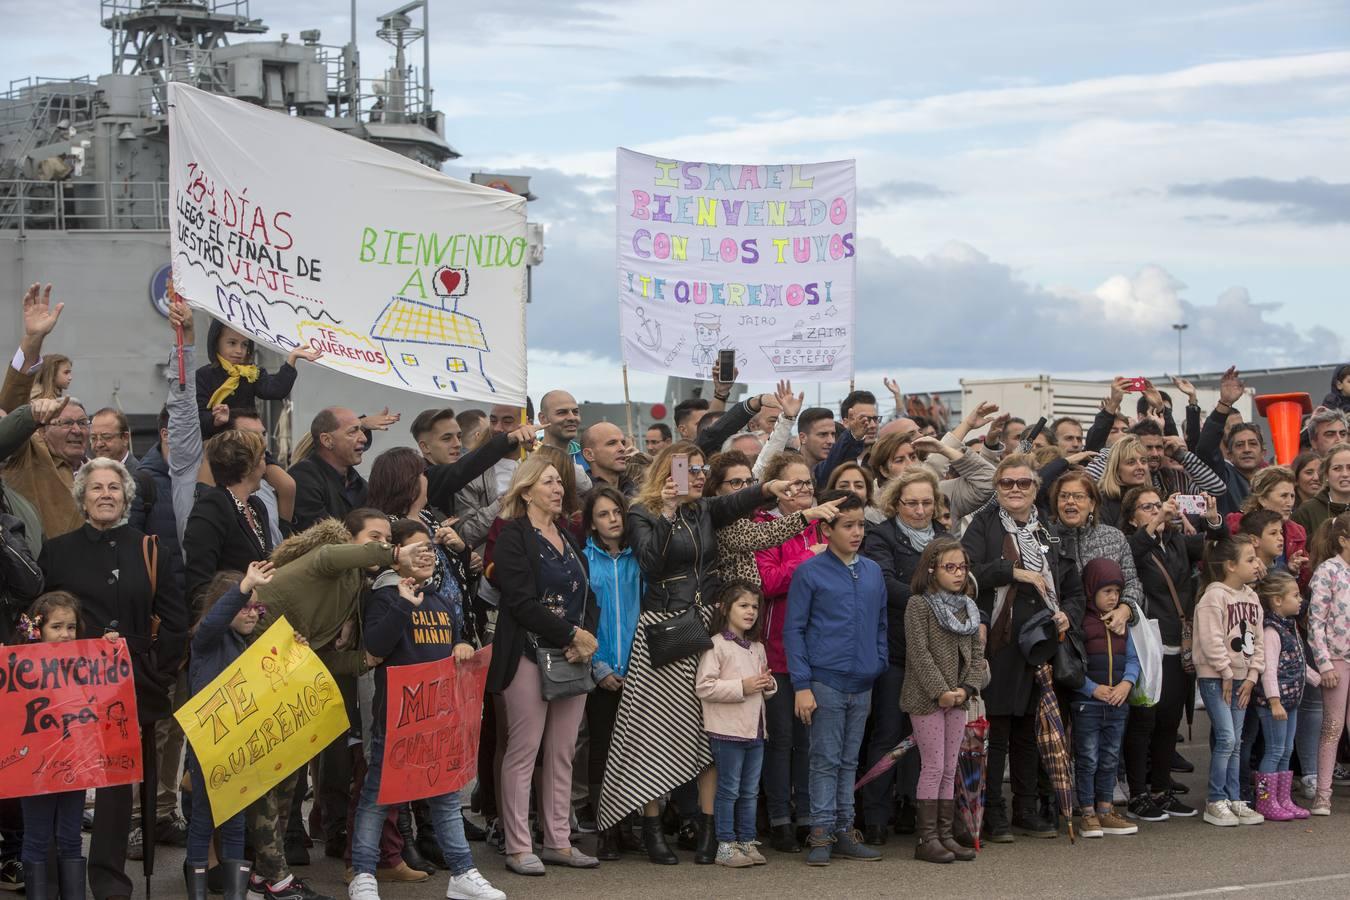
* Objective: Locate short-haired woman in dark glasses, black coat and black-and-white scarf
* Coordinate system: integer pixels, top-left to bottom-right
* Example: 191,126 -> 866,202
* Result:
961,453 -> 1085,842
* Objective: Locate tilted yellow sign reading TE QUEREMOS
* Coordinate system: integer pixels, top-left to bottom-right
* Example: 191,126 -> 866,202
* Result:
174,617 -> 348,824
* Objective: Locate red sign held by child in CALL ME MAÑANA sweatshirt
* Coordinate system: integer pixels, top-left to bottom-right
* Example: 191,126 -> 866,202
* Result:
375,646 -> 493,804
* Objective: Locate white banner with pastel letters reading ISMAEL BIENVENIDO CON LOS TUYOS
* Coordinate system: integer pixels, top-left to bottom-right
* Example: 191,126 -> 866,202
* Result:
617,148 -> 856,382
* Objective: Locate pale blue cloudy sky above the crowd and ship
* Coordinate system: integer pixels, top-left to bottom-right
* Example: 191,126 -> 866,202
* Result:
0,0 -> 1350,399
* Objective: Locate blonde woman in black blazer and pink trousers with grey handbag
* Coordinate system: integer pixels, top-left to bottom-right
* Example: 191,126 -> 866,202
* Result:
487,453 -> 599,876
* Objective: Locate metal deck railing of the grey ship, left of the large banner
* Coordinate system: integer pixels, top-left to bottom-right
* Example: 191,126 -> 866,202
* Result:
0,178 -> 169,231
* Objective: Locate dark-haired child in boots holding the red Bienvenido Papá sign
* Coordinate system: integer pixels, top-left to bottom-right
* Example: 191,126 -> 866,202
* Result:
19,591 -> 120,900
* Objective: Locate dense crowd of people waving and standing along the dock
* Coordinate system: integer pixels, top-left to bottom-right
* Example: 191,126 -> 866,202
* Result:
0,285 -> 1350,900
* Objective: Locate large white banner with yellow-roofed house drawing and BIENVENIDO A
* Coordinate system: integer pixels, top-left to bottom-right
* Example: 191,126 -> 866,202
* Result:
169,84 -> 527,405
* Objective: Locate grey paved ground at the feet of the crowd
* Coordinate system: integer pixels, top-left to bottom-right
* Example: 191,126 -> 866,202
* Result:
128,712 -> 1350,900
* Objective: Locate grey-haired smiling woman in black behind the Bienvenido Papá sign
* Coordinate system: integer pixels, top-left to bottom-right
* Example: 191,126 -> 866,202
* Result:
38,456 -> 188,897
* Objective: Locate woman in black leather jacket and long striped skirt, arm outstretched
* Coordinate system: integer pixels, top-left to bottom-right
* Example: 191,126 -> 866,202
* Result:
598,441 -> 788,865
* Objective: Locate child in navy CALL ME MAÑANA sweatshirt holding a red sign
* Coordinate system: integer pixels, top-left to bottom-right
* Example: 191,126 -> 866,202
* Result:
347,518 -> 506,900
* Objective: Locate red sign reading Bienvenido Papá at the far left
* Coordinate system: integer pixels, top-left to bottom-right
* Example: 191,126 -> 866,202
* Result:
0,638 -> 140,797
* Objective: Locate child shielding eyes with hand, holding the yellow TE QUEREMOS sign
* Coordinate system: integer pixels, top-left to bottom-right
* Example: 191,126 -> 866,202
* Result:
182,561 -> 274,900
